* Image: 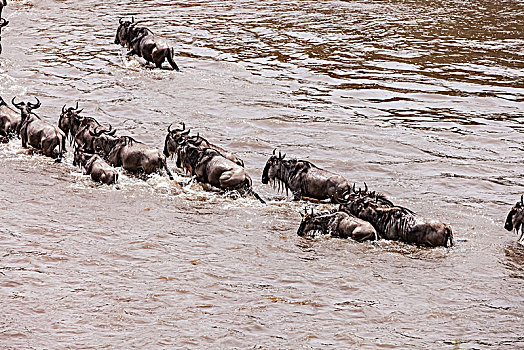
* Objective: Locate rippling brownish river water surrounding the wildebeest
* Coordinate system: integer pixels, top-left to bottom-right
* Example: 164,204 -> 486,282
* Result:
0,0 -> 524,349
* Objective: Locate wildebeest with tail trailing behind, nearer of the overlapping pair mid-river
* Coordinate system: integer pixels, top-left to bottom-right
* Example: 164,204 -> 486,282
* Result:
176,138 -> 265,203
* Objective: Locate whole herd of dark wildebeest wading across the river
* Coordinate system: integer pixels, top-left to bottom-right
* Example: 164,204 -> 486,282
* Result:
0,9 -> 524,247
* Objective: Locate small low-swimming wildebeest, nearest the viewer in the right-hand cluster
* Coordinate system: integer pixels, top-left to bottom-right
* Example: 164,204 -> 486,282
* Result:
297,210 -> 378,242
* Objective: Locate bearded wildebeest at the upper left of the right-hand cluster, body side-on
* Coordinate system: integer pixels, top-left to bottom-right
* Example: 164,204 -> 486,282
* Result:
262,150 -> 351,203
